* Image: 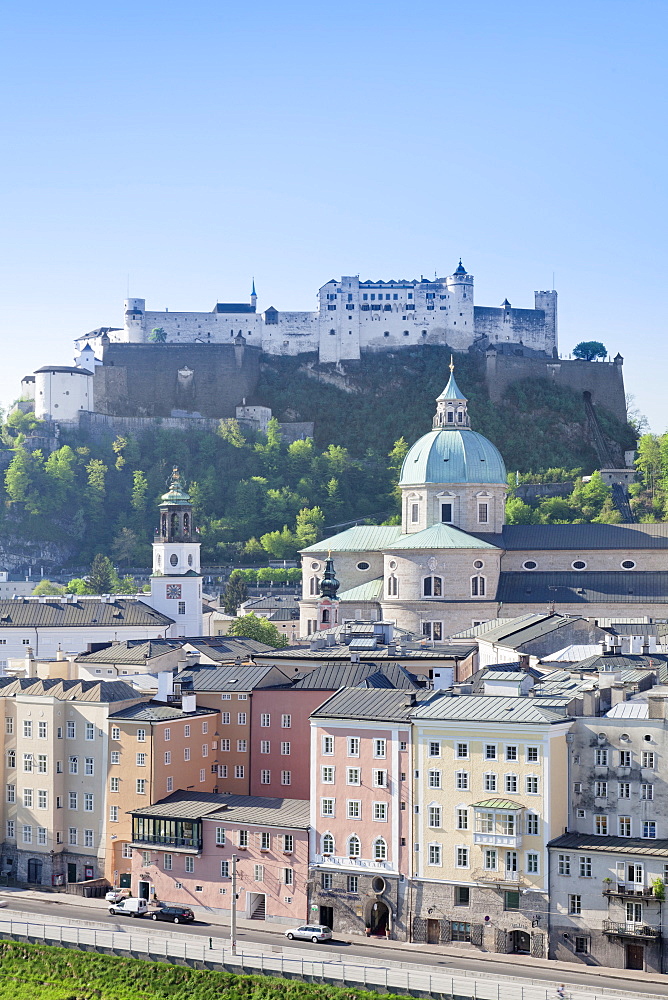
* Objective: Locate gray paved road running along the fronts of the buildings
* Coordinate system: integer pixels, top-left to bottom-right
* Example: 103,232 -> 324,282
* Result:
0,895 -> 668,998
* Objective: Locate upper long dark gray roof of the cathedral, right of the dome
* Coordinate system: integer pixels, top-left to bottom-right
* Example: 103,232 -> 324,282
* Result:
494,524 -> 668,551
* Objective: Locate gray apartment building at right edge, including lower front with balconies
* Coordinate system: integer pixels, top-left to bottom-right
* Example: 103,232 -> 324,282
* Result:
549,687 -> 668,972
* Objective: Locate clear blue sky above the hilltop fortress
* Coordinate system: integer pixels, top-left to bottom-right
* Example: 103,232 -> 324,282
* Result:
0,0 -> 668,433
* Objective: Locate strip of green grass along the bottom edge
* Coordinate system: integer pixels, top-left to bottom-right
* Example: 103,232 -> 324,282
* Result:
0,941 -> 407,1000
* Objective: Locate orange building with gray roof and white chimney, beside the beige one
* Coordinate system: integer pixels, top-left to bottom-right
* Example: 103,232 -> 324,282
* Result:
105,695 -> 220,888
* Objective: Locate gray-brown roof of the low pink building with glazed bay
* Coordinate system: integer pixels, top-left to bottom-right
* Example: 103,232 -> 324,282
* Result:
132,792 -> 310,830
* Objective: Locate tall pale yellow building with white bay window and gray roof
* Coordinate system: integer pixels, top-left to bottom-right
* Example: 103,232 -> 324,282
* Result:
412,694 -> 572,957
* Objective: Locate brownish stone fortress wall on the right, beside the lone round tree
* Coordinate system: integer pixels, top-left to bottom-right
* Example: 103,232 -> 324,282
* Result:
486,352 -> 626,422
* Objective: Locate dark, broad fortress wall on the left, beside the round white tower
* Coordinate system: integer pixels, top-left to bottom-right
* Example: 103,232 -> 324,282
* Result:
95,344 -> 260,419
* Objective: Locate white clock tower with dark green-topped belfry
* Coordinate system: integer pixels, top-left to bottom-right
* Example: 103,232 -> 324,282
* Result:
150,468 -> 203,636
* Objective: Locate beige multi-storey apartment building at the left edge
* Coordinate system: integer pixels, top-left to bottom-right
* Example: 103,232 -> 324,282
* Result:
0,678 -> 140,886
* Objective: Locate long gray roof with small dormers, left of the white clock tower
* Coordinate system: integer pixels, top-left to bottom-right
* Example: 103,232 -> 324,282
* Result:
0,597 -> 174,628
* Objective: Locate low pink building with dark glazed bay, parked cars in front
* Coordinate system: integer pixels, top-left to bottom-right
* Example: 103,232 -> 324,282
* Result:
132,792 -> 309,924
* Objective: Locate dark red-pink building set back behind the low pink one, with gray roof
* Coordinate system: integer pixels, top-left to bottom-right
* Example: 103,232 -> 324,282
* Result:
250,661 -> 417,799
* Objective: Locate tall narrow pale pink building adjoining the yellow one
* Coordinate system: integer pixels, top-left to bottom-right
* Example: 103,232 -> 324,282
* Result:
310,688 -> 422,940
